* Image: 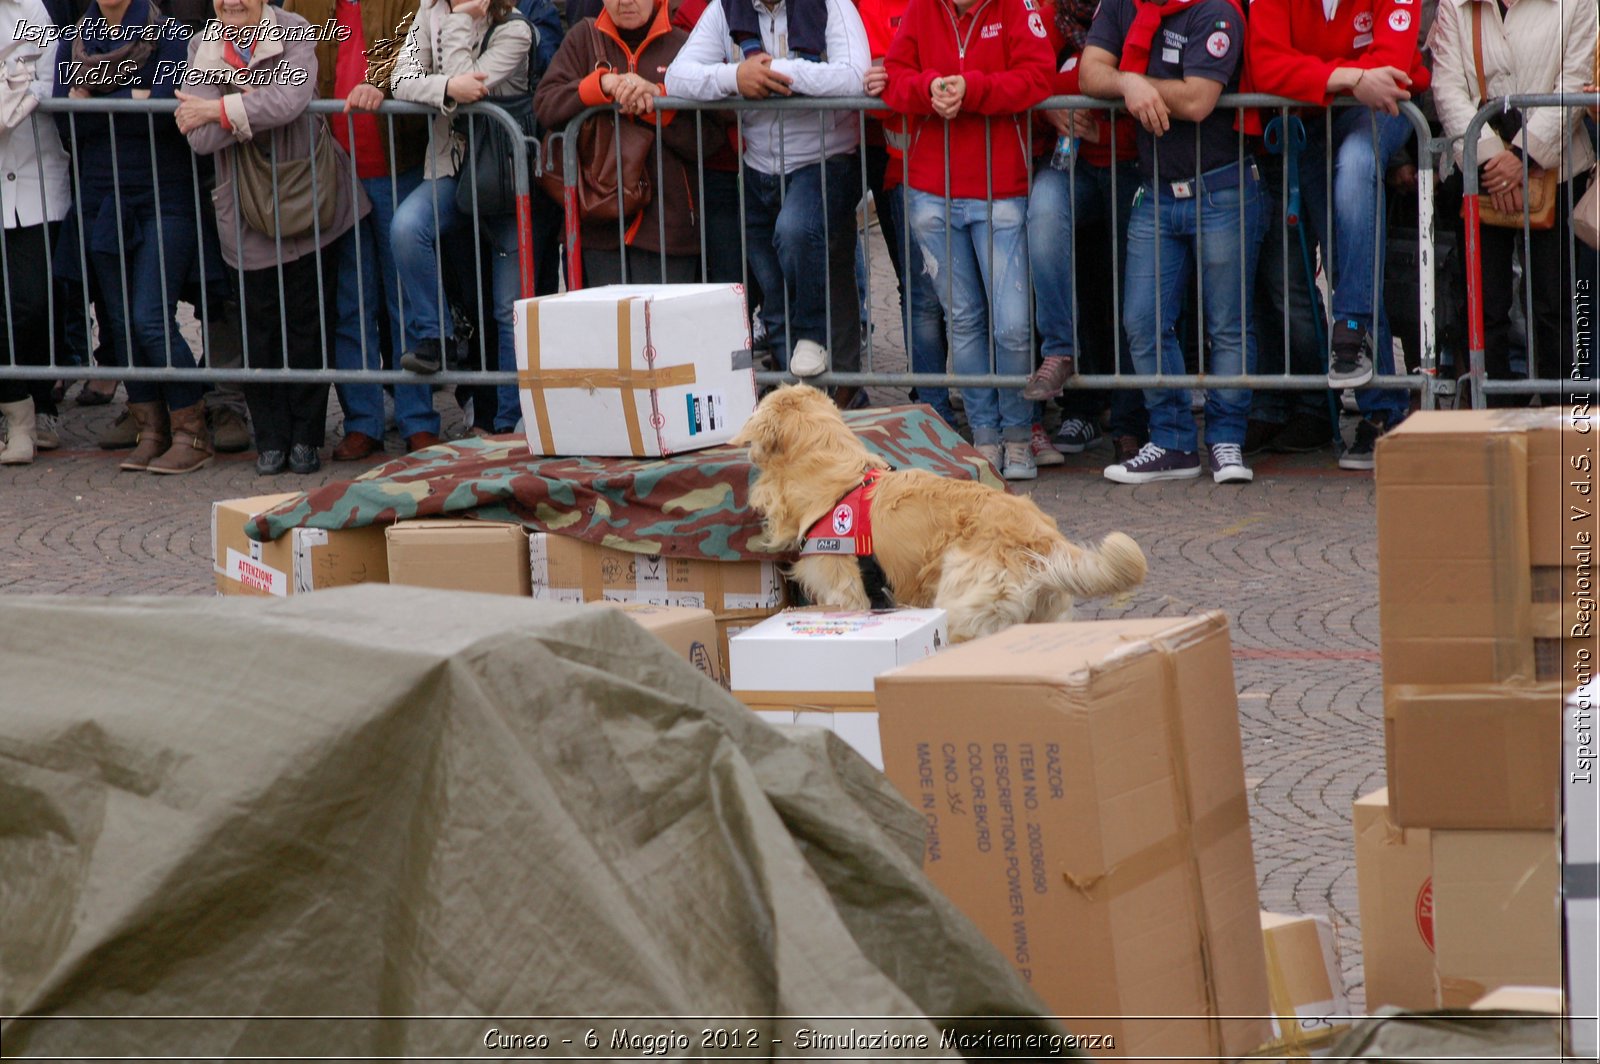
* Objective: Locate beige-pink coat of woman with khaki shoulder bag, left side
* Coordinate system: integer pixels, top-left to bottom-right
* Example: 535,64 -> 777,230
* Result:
184,6 -> 373,270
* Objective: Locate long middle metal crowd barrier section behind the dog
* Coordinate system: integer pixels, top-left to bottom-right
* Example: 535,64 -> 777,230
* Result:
562,94 -> 1453,406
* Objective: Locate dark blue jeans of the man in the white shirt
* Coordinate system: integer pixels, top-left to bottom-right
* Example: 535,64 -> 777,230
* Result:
744,154 -> 861,373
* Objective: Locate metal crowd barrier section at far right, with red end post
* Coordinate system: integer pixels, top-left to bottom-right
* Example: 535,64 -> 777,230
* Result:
1461,93 -> 1600,408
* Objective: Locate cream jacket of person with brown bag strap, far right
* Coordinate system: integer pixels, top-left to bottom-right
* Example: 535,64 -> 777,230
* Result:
1427,0 -> 1597,181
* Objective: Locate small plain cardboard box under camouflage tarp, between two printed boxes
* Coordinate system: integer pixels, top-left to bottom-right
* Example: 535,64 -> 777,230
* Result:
389,518 -> 530,595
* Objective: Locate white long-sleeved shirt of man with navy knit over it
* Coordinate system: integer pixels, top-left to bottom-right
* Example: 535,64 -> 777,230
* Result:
667,0 -> 872,174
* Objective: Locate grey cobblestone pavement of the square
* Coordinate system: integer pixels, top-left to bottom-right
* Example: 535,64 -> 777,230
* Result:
0,225 -> 1384,1008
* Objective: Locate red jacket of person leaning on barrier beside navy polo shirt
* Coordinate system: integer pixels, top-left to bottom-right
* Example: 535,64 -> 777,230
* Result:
1246,0 -> 1429,107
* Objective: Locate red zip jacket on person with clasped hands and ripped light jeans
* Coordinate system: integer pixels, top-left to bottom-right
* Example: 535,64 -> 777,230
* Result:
883,0 -> 1056,200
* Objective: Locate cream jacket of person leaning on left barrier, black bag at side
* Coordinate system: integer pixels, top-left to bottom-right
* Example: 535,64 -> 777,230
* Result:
389,0 -> 533,178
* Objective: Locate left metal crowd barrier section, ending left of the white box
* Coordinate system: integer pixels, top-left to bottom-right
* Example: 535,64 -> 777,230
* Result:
0,99 -> 539,386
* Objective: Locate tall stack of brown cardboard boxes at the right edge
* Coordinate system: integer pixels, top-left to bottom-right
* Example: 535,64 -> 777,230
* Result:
1357,408 -> 1574,1008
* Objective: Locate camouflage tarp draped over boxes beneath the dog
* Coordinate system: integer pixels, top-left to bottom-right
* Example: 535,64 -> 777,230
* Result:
246,406 -> 1005,562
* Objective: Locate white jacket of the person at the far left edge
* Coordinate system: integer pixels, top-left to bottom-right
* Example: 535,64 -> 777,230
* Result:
0,0 -> 70,228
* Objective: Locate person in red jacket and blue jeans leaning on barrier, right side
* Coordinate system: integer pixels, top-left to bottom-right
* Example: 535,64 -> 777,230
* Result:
1248,0 -> 1429,469
